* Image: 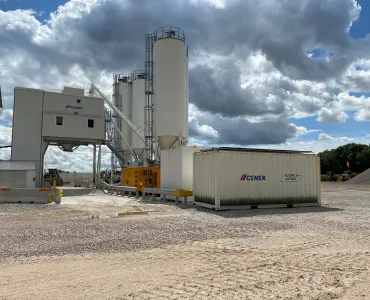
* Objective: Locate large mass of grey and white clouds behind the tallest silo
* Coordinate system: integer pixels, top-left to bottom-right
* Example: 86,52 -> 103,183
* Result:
0,0 -> 370,171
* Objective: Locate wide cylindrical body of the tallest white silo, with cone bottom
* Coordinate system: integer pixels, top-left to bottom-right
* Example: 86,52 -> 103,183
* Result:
153,38 -> 188,149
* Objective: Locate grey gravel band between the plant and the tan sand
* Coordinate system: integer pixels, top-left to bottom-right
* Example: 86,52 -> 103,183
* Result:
0,185 -> 370,261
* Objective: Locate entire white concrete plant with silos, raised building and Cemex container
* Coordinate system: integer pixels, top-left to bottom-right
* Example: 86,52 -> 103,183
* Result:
2,27 -> 320,209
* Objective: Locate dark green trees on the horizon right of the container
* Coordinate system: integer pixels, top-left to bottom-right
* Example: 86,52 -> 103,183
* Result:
319,143 -> 370,174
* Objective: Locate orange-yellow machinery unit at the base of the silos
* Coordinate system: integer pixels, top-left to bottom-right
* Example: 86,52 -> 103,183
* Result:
121,167 -> 161,192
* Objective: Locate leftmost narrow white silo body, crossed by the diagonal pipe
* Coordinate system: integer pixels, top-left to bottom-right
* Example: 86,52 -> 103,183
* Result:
119,82 -> 134,150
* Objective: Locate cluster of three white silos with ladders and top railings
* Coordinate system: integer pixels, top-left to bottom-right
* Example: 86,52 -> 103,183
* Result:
113,27 -> 188,164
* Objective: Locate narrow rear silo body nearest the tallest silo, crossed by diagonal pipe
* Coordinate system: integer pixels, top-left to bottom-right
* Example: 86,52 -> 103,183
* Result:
132,79 -> 145,149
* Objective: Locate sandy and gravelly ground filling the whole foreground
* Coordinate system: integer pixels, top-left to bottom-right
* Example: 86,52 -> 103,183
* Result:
0,184 -> 370,300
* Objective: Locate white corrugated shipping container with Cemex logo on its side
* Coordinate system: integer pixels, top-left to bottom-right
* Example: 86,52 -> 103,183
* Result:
193,148 -> 320,210
